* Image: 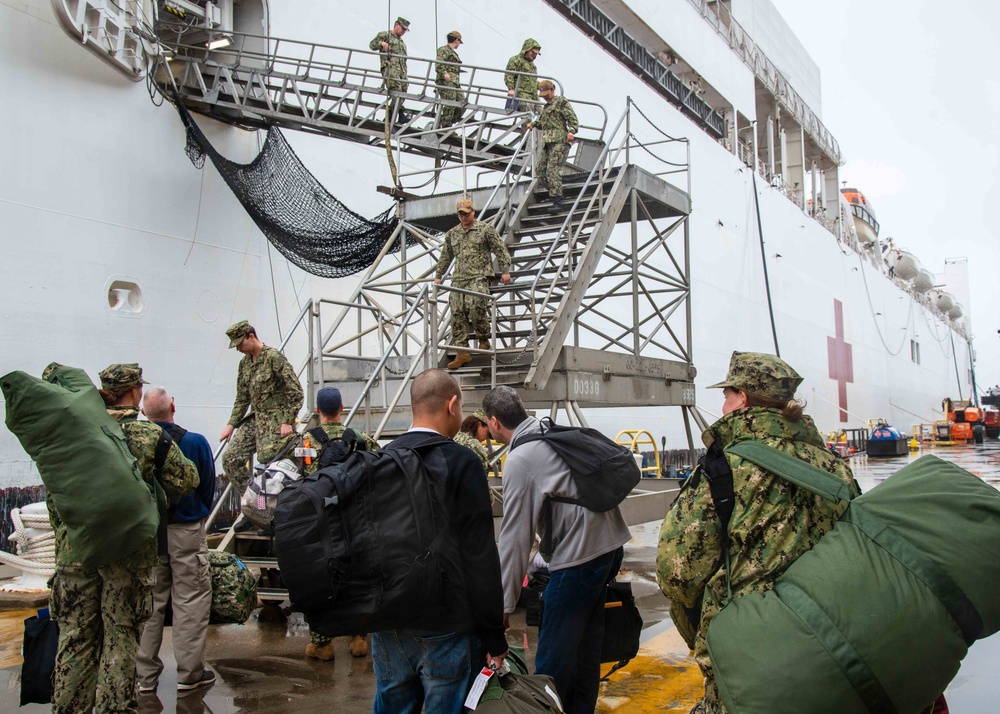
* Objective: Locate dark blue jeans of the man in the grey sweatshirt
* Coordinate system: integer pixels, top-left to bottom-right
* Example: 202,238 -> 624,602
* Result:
535,548 -> 624,714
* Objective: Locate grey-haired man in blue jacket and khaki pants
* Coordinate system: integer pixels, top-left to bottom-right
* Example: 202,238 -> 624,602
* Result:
136,387 -> 215,694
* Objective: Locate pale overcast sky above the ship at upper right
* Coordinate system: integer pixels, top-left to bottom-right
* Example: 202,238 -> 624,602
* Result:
772,0 -> 1000,389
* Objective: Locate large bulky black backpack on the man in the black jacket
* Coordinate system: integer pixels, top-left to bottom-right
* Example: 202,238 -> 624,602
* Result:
274,432 -> 457,637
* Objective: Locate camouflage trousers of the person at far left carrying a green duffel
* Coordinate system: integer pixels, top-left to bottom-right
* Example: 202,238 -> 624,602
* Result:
49,562 -> 153,714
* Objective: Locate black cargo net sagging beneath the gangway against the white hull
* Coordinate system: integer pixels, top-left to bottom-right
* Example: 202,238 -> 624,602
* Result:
175,101 -> 416,278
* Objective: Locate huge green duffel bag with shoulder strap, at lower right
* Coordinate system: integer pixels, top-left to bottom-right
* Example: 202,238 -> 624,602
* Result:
708,442 -> 1000,714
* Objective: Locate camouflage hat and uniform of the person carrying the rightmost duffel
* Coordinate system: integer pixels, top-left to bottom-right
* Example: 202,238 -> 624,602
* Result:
656,353 -> 854,714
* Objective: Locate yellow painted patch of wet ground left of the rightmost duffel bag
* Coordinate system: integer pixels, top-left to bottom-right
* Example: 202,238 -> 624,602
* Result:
597,620 -> 704,714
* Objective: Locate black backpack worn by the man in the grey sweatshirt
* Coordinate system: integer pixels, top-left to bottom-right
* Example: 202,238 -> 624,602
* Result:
510,417 -> 642,513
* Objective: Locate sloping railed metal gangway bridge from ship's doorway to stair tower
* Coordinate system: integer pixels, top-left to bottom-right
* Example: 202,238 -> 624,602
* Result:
155,21 -> 608,188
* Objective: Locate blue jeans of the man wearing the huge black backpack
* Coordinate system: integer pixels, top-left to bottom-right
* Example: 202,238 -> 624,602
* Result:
372,631 -> 486,714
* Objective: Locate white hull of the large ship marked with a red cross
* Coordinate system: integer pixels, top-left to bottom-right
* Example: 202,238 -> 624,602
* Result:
0,0 -> 970,486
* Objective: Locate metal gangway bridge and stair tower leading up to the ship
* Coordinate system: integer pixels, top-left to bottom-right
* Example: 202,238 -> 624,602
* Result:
158,23 -> 704,598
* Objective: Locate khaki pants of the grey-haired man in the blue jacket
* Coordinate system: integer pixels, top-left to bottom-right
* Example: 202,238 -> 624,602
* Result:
136,520 -> 212,687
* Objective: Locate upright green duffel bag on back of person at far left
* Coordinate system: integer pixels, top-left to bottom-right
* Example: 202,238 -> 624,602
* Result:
0,366 -> 160,568
